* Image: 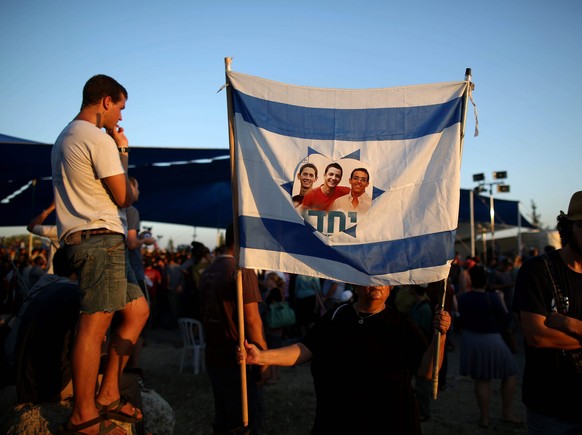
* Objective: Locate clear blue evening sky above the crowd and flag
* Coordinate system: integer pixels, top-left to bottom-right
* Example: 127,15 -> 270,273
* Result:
0,0 -> 582,249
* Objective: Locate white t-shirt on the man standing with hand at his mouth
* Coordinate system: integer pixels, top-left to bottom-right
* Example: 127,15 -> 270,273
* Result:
51,120 -> 127,240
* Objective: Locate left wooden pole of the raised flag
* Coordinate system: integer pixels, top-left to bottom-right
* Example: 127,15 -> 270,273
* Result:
224,57 -> 249,428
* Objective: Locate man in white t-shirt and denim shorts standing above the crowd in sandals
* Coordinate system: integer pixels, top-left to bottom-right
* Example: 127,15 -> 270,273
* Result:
51,75 -> 149,435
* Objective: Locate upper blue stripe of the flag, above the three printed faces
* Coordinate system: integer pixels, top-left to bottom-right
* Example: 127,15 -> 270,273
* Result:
233,89 -> 462,141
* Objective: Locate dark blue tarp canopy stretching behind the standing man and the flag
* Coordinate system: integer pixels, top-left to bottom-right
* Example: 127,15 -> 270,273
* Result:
0,134 -> 533,235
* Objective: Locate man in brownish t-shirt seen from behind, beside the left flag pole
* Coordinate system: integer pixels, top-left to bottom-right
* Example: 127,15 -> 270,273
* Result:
200,225 -> 268,435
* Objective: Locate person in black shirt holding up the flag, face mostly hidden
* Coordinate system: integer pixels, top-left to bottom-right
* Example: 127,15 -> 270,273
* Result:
237,286 -> 451,435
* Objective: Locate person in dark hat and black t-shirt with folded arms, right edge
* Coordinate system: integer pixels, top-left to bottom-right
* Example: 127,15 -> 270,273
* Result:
513,191 -> 582,434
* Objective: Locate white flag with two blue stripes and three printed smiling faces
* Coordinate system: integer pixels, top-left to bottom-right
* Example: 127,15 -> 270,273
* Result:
227,71 -> 469,285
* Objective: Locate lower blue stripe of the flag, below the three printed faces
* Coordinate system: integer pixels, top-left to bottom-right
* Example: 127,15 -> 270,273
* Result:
239,216 -> 455,276
